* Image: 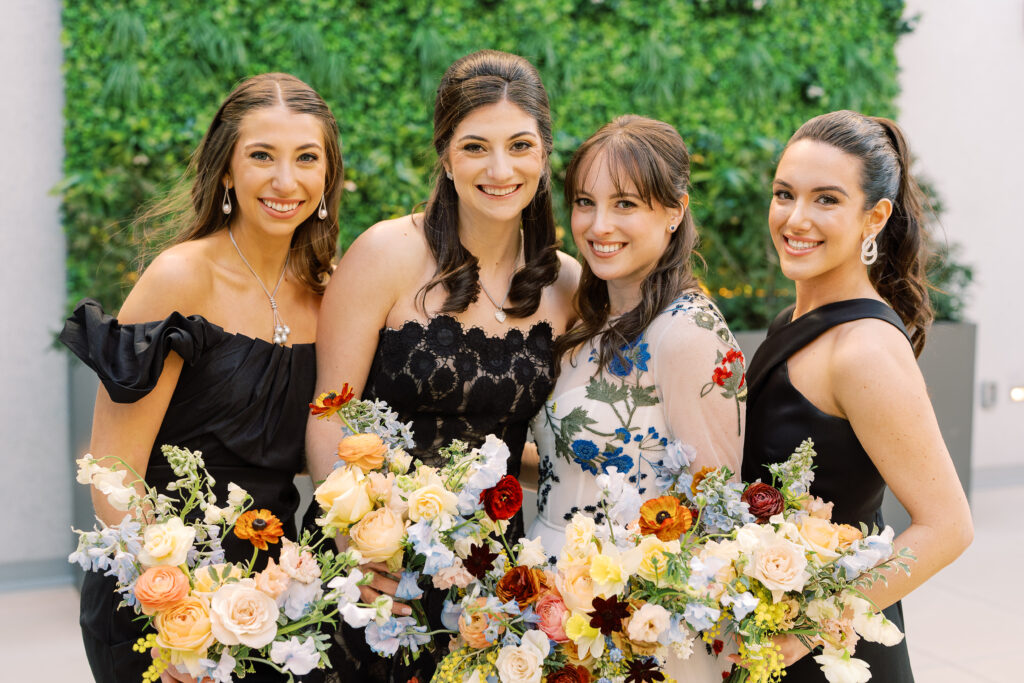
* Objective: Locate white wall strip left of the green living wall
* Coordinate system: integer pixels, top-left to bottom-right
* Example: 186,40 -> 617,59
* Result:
0,0 -> 73,590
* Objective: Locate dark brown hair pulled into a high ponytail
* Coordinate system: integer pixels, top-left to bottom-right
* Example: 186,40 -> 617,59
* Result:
786,110 -> 935,355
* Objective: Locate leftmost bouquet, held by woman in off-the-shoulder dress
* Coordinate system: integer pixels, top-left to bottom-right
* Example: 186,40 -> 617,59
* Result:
69,445 -> 359,683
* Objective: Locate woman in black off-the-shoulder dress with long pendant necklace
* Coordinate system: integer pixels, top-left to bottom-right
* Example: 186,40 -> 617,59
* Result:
60,74 -> 342,683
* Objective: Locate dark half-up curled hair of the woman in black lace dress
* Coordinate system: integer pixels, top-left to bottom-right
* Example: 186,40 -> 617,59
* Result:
417,50 -> 559,317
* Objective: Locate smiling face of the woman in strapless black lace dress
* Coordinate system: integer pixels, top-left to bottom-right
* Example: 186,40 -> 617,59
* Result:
444,100 -> 545,225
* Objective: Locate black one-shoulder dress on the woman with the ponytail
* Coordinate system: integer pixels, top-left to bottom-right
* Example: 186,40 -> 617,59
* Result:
742,299 -> 913,683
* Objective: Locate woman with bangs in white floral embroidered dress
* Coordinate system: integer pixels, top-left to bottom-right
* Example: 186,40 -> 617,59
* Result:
527,116 -> 746,681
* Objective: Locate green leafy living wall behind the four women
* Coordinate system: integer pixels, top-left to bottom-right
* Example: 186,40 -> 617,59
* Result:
59,0 -> 937,329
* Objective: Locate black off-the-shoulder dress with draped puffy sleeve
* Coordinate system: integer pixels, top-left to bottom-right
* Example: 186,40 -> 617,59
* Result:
60,299 -> 322,683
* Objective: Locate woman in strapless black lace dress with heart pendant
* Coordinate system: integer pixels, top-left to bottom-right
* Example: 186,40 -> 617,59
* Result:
306,50 -> 579,683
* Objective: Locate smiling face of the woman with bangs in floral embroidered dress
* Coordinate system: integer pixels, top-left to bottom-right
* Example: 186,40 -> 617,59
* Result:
571,153 -> 686,314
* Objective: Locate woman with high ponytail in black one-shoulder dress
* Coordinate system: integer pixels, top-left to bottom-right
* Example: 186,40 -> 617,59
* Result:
742,112 -> 973,683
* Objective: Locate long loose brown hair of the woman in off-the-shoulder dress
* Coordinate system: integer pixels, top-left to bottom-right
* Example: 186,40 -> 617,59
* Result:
136,74 -> 344,294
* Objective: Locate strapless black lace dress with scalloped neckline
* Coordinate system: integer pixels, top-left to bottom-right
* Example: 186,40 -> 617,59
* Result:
321,315 -> 554,683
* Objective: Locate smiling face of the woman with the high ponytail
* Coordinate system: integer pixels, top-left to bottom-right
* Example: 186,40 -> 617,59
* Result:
768,139 -> 889,288
